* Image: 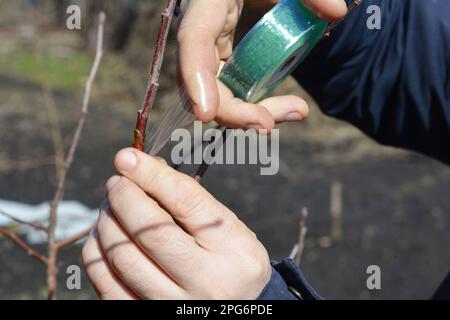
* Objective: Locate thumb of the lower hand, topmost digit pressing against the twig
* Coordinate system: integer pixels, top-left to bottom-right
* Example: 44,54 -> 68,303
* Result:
115,149 -> 243,249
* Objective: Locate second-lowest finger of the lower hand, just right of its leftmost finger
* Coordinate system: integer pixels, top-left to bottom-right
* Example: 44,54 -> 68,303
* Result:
98,210 -> 184,300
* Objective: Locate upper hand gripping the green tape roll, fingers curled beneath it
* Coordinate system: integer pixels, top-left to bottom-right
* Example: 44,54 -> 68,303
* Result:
178,0 -> 347,131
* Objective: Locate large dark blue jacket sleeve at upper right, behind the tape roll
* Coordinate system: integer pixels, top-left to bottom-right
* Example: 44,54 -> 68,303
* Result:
294,0 -> 450,164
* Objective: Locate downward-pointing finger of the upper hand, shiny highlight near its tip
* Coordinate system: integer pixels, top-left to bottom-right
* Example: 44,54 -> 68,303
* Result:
178,0 -> 241,122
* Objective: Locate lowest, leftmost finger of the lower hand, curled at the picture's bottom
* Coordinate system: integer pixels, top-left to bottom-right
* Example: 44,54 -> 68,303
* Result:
82,237 -> 136,300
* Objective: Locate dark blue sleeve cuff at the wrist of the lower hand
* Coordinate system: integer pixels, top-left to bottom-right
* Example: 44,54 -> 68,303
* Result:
258,259 -> 322,300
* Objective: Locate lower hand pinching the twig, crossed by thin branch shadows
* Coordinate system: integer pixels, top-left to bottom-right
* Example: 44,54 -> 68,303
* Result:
82,149 -> 271,299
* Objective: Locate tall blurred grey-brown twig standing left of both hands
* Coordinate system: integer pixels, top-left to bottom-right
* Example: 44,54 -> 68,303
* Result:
47,12 -> 106,299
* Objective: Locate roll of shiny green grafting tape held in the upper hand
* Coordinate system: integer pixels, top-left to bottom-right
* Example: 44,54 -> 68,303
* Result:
219,0 -> 328,103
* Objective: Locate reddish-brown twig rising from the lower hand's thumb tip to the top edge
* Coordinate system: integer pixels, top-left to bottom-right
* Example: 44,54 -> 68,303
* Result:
133,0 -> 177,151
